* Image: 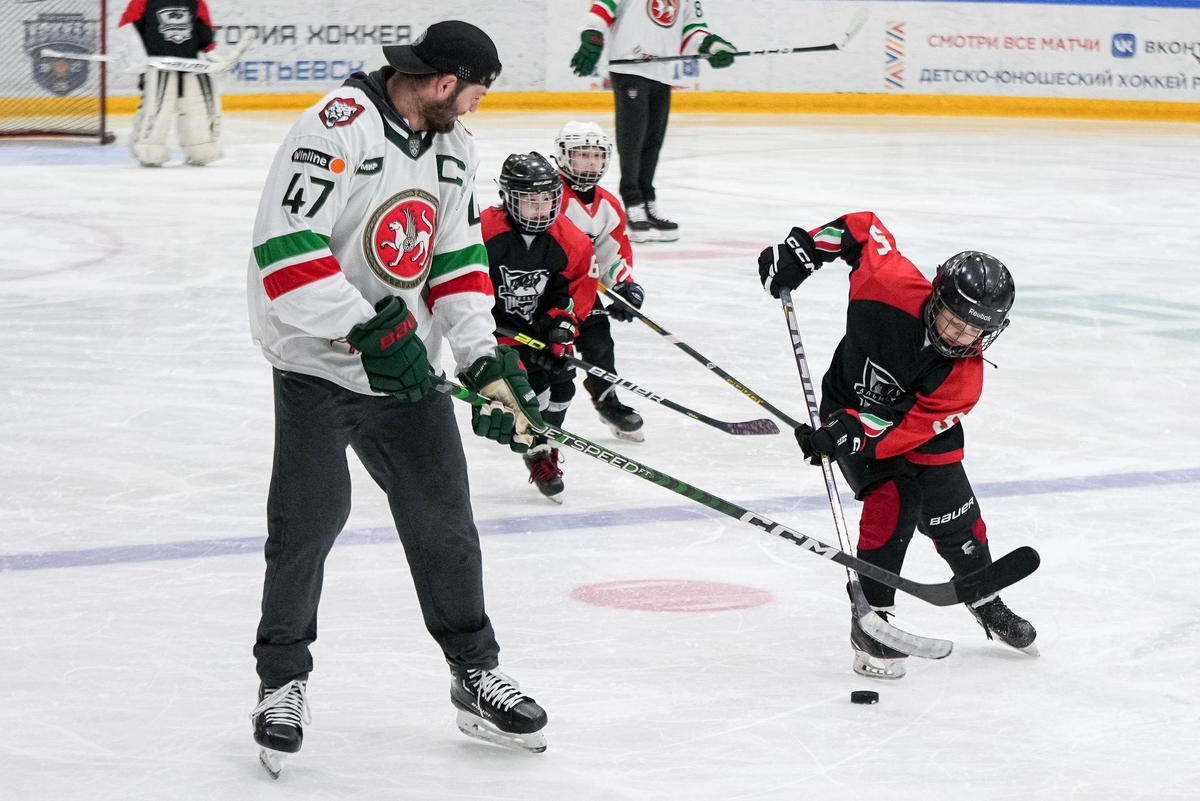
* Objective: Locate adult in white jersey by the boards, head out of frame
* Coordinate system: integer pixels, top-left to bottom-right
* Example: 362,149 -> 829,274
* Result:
571,0 -> 737,242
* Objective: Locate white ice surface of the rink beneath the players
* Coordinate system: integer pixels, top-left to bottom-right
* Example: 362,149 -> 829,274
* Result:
0,114 -> 1200,801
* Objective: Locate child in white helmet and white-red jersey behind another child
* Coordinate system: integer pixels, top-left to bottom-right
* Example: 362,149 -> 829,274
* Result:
554,121 -> 646,442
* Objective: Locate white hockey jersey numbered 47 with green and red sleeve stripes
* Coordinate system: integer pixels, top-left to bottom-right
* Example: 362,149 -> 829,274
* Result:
247,68 -> 496,395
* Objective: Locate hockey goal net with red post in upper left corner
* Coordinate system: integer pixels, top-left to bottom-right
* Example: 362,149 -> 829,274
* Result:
0,0 -> 113,143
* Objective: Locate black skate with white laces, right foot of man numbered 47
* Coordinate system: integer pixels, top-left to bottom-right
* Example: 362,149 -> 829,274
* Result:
450,664 -> 546,753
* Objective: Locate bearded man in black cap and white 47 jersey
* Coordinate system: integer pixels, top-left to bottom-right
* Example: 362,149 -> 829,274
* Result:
248,20 -> 546,776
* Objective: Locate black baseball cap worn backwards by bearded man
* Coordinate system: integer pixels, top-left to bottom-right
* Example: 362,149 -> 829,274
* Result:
383,19 -> 500,86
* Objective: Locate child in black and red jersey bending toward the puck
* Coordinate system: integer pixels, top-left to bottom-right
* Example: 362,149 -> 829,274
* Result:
758,212 -> 1037,679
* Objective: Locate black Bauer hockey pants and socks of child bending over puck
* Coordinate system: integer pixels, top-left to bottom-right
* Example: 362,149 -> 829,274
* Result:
838,456 -> 991,607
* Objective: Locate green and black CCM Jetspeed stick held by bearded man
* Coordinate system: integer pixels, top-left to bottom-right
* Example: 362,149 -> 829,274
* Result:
433,375 -> 1040,607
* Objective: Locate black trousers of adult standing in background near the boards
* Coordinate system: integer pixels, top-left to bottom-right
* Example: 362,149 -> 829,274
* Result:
608,72 -> 671,209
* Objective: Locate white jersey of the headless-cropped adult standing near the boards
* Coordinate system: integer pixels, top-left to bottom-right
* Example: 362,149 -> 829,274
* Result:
583,0 -> 712,84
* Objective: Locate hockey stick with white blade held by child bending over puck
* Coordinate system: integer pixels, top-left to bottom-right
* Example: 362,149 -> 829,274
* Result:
779,288 -> 954,660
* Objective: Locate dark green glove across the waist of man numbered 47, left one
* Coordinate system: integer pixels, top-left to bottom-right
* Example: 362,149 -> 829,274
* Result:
346,295 -> 433,403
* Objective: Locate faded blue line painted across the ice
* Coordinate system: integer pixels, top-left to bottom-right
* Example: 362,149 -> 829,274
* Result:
0,468 -> 1200,573
